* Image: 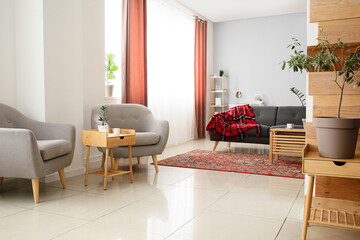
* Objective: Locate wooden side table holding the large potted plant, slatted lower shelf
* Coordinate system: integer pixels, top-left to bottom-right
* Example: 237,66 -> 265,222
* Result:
302,144 -> 360,240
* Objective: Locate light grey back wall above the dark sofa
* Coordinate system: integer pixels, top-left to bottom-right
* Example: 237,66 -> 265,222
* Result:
214,13 -> 306,105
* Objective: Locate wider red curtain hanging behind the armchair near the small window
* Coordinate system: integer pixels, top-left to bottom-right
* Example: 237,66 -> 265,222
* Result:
121,0 -> 147,106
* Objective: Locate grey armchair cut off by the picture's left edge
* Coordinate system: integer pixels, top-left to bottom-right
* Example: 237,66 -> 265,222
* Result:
0,103 -> 75,203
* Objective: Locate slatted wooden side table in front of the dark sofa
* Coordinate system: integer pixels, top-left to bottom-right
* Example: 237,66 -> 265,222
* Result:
269,128 -> 305,164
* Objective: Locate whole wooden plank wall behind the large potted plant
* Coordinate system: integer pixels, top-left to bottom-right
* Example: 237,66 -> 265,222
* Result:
306,0 -> 360,204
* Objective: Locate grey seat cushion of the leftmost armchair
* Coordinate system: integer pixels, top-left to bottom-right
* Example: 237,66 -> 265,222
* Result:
37,139 -> 71,161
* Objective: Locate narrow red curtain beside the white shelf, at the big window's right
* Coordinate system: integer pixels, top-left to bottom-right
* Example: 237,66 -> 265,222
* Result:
194,18 -> 207,139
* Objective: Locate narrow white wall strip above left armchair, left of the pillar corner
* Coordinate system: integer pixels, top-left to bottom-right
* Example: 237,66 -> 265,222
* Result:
15,0 -> 45,121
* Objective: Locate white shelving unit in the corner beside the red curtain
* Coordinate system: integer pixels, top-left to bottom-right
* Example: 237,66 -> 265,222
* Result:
209,75 -> 229,117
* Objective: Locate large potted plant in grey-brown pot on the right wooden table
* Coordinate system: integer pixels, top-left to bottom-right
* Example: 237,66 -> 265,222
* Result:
282,39 -> 360,158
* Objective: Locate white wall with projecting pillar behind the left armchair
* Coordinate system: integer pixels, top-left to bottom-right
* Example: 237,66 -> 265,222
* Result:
0,0 -> 105,181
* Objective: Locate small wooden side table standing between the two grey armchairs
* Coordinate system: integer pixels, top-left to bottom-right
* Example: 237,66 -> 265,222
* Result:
82,129 -> 136,190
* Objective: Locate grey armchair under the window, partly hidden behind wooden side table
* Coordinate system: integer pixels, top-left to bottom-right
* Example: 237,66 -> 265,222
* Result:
91,104 -> 169,172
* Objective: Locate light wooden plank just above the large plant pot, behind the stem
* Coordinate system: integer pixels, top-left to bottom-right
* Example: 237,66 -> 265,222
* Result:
313,95 -> 360,117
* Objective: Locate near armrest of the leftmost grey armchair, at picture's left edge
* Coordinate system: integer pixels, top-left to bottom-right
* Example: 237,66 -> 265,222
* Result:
0,128 -> 44,178
